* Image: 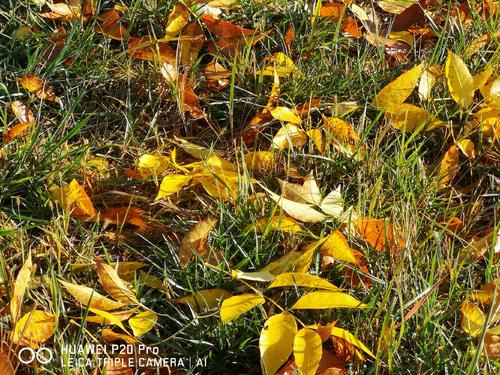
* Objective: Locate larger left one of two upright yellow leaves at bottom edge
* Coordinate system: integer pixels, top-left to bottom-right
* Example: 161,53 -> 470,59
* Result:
259,313 -> 297,375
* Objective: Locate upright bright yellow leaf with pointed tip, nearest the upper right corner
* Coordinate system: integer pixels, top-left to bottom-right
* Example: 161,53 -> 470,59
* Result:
445,51 -> 476,108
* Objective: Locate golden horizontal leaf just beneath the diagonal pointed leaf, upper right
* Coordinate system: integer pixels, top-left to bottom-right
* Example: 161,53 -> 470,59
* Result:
385,103 -> 445,132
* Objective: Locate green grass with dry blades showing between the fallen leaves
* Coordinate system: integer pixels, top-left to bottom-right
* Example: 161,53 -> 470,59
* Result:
0,0 -> 500,374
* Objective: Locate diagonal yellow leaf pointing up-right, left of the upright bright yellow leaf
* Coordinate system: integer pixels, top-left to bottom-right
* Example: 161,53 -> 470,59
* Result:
372,63 -> 424,112
